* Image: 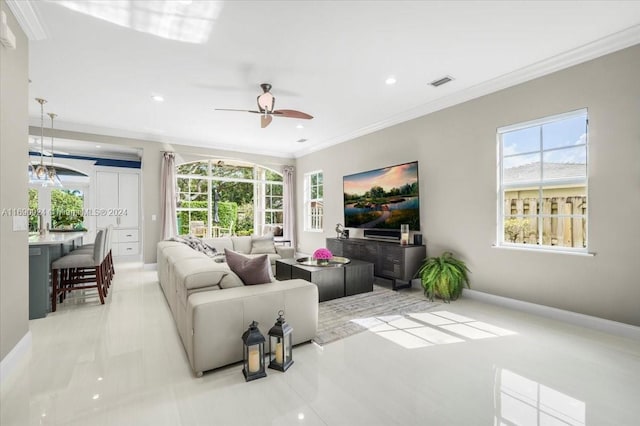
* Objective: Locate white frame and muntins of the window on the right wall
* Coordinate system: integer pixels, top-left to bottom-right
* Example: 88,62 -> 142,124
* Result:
495,108 -> 590,254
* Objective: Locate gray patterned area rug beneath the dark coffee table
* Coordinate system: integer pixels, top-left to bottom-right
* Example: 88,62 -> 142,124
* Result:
313,284 -> 439,346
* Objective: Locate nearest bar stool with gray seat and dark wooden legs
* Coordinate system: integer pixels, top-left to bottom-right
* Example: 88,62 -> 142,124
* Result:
51,230 -> 107,312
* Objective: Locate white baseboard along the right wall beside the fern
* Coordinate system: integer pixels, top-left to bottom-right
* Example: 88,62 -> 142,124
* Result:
463,289 -> 640,341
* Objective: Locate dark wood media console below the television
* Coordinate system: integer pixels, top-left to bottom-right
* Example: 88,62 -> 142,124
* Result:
327,238 -> 427,290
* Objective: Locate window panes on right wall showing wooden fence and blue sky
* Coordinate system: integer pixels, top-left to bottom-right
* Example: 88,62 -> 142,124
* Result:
498,110 -> 588,251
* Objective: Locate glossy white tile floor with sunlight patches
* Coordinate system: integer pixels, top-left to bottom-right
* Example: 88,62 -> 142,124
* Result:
0,264 -> 640,426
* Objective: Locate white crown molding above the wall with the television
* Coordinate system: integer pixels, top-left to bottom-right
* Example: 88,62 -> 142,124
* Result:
294,25 -> 640,158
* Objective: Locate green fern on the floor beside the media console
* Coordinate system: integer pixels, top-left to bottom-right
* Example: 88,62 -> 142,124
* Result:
416,251 -> 470,303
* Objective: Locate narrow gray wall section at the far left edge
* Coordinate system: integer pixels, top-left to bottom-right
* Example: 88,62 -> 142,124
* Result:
0,0 -> 29,359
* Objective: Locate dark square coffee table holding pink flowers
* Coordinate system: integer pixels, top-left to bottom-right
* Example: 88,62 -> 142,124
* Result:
276,257 -> 373,302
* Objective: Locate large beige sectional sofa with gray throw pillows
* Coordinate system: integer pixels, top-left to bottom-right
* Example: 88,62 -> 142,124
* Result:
157,237 -> 318,376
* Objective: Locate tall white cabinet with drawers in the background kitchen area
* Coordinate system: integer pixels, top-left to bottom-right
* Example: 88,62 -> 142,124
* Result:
96,169 -> 140,256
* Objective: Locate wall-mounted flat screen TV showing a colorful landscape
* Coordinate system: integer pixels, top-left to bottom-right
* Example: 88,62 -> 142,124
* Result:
343,161 -> 420,231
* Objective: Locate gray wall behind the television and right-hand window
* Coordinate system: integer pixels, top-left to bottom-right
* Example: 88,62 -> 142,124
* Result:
297,45 -> 640,325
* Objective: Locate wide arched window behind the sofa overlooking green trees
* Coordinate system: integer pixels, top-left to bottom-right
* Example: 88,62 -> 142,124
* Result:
176,160 -> 283,237
